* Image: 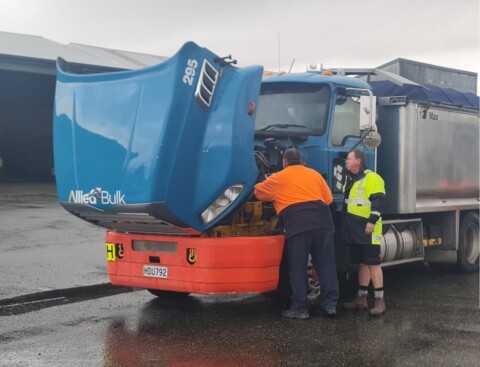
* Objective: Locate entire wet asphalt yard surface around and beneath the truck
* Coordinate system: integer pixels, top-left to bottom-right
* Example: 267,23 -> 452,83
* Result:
0,185 -> 480,366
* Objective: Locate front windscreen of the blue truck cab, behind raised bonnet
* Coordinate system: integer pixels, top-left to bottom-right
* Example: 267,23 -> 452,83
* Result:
255,82 -> 331,135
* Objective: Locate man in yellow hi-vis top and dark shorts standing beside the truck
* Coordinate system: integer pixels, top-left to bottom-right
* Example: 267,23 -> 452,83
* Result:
342,150 -> 386,316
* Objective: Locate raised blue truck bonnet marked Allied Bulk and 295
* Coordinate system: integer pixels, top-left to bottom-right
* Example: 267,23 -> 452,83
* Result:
53,42 -> 263,234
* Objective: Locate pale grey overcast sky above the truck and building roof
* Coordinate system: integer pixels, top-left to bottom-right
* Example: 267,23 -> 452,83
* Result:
0,0 -> 480,77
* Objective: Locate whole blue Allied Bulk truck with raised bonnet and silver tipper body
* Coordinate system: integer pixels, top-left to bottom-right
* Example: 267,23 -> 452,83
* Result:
54,42 -> 479,296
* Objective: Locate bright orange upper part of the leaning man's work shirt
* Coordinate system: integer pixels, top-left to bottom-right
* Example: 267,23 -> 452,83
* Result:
255,164 -> 333,214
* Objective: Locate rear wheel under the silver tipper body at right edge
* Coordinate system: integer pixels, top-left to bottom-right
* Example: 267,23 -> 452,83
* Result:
455,212 -> 480,273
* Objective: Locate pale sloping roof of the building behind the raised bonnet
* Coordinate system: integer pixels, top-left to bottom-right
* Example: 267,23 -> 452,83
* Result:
0,32 -> 167,73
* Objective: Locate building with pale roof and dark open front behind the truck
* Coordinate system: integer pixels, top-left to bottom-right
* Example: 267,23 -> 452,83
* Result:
0,32 -> 166,182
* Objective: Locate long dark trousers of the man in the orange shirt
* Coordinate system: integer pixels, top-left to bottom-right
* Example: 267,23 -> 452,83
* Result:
286,230 -> 339,312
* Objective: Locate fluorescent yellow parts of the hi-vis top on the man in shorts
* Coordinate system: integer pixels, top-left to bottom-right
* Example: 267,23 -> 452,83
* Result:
343,169 -> 385,245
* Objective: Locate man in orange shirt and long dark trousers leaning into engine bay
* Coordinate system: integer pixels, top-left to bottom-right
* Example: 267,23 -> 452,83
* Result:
255,148 -> 339,319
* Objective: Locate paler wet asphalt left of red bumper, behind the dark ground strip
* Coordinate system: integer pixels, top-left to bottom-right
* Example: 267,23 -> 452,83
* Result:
0,183 -> 108,299
